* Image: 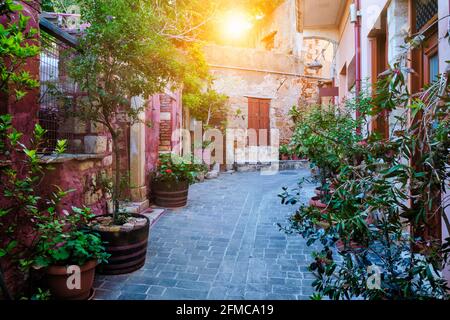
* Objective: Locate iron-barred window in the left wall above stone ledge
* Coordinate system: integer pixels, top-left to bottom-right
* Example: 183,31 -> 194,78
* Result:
39,31 -> 83,153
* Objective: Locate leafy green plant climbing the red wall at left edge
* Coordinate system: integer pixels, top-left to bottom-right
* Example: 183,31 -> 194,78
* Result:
0,114 -> 68,298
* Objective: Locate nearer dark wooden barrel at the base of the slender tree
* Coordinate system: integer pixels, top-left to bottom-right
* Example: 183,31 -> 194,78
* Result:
96,214 -> 150,274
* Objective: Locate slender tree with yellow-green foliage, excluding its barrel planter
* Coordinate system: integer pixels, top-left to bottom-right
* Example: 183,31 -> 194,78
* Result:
69,0 -> 185,224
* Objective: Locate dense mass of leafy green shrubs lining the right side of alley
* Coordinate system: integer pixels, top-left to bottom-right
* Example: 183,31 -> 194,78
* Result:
280,48 -> 450,300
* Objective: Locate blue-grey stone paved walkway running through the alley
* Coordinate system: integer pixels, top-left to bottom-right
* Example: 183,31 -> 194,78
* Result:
95,169 -> 313,300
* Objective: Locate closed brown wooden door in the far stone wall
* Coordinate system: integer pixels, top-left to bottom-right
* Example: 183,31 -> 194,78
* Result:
248,98 -> 270,146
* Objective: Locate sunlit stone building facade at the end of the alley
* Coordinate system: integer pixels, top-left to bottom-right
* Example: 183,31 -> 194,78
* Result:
204,0 -> 334,165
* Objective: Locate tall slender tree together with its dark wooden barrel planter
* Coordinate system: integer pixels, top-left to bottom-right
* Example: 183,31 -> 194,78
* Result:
64,0 -> 185,274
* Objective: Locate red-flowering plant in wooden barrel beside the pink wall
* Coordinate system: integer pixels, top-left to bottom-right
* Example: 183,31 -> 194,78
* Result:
151,154 -> 207,208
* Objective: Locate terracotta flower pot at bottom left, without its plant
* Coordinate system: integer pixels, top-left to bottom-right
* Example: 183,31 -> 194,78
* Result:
46,260 -> 97,300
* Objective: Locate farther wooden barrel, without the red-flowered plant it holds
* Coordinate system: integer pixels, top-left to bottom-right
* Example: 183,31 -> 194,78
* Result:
152,181 -> 189,208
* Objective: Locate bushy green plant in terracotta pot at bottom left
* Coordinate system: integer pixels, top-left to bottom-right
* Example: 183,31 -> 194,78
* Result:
34,208 -> 109,300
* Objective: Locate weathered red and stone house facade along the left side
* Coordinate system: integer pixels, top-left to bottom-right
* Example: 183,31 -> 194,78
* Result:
0,1 -> 182,214
